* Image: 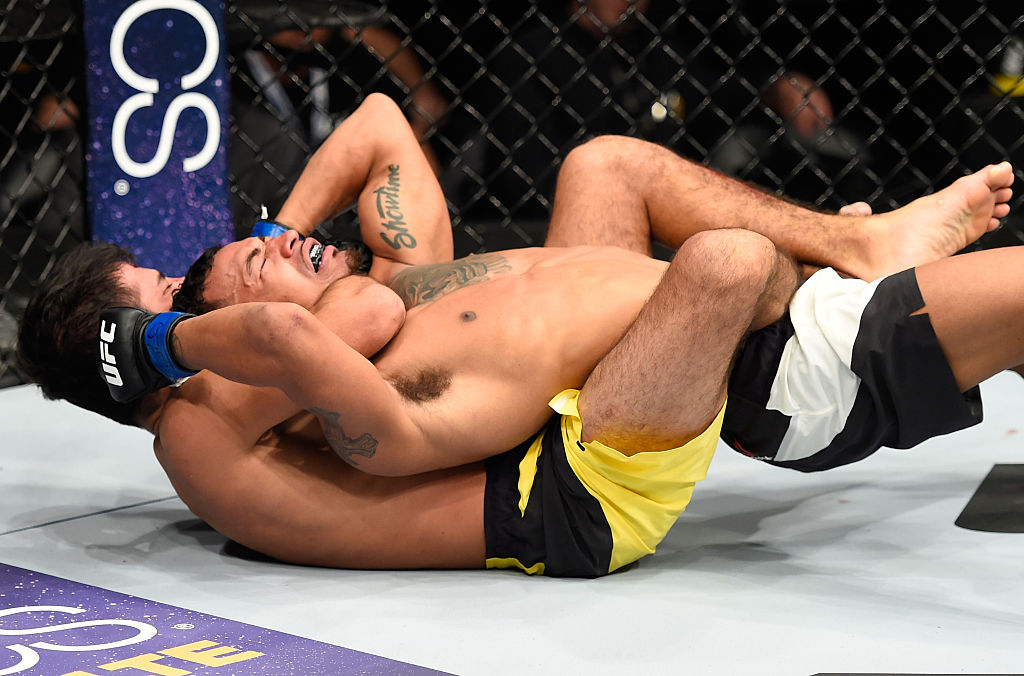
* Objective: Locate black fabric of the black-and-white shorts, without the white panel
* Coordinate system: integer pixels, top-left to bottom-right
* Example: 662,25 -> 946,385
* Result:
722,269 -> 982,472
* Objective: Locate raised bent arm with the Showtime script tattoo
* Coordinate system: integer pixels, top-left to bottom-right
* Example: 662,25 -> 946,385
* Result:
278,94 -> 454,281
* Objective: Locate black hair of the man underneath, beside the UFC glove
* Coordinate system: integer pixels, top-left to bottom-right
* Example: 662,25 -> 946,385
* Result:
15,242 -> 144,425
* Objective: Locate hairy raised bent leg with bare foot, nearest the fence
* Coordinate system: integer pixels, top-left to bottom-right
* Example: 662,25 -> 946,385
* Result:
546,136 -> 1013,279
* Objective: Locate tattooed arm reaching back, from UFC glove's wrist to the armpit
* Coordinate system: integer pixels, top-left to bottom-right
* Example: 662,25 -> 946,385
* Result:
169,303 -> 427,474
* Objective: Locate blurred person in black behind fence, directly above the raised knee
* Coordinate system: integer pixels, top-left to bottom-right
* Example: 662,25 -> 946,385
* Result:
478,0 -> 716,218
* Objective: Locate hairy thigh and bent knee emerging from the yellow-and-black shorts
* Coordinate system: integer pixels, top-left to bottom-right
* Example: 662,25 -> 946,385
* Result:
580,229 -> 797,455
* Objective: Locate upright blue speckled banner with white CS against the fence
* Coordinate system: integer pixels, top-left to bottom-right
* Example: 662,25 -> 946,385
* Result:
83,0 -> 233,277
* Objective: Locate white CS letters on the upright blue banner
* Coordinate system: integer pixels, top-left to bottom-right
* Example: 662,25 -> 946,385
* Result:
111,0 -> 220,178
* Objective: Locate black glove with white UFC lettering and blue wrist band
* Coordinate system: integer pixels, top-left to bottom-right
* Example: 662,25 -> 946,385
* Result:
99,307 -> 198,403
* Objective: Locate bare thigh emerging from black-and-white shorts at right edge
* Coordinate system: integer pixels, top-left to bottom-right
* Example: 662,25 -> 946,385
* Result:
918,247 -> 1024,390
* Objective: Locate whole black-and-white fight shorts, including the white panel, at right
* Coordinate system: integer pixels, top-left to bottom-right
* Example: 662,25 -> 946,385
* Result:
722,268 -> 982,472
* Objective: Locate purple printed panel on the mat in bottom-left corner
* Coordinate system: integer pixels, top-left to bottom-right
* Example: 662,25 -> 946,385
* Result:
0,563 -> 443,676
